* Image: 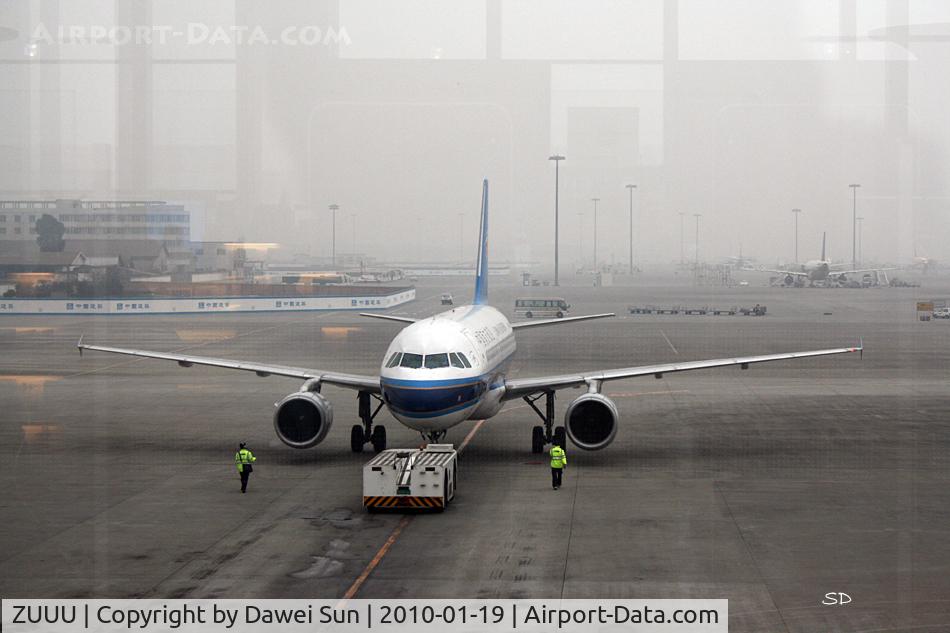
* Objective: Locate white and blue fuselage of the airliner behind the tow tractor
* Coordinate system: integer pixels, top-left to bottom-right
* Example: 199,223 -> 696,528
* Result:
380,305 -> 515,432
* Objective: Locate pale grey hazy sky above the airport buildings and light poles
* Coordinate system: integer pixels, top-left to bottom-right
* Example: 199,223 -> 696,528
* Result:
0,0 -> 950,270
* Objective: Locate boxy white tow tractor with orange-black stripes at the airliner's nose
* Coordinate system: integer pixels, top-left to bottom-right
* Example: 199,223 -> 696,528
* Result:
363,444 -> 458,512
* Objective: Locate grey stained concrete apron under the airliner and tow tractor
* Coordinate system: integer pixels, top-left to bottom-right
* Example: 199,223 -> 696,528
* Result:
0,278 -> 950,632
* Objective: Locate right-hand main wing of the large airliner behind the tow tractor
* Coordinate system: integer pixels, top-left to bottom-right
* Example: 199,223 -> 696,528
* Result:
504,343 -> 864,400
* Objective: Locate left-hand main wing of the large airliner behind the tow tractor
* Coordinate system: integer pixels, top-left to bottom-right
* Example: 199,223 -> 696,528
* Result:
76,337 -> 380,393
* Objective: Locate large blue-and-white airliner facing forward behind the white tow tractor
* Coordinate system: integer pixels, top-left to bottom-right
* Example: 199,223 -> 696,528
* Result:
77,180 -> 863,453
